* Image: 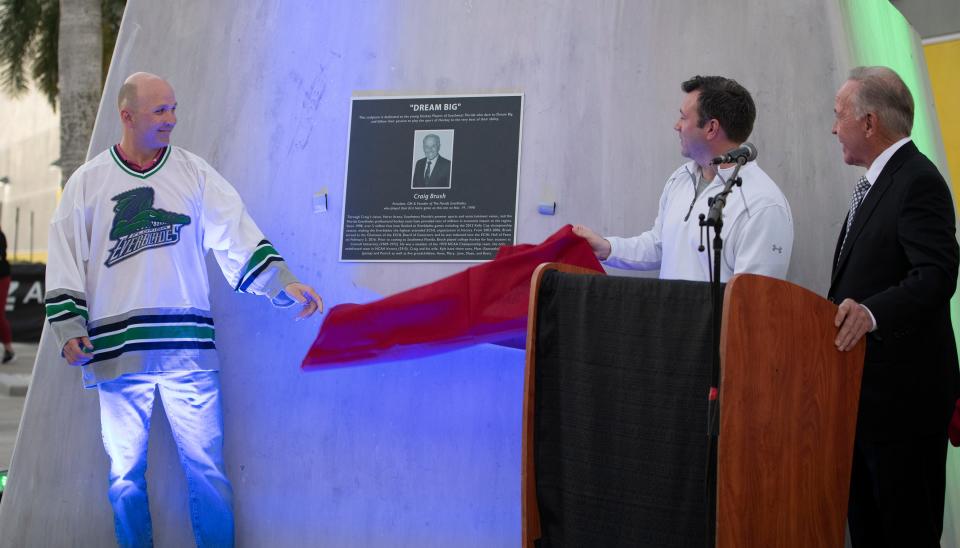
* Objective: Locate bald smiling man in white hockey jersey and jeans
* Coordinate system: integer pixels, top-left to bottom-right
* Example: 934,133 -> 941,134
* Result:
46,73 -> 323,546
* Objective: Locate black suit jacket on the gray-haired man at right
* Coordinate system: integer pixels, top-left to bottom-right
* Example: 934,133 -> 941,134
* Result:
828,141 -> 960,441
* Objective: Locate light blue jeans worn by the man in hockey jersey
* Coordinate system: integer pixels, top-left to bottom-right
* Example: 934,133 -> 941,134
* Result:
98,371 -> 233,547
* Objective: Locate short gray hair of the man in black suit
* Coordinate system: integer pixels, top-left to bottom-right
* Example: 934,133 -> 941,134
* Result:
849,67 -> 913,137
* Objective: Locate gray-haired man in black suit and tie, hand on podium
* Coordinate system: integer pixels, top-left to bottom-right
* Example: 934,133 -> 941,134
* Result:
829,67 -> 960,548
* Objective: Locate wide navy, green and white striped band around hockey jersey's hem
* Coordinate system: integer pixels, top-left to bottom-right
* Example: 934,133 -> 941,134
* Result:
90,314 -> 216,363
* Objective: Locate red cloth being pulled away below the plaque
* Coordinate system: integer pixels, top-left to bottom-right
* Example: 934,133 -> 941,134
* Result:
301,225 -> 603,369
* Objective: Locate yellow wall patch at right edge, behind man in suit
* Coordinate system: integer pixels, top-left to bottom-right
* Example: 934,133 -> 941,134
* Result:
923,39 -> 960,197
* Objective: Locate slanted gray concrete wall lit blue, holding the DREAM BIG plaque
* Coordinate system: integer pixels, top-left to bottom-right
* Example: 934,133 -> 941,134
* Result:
0,0 -> 948,547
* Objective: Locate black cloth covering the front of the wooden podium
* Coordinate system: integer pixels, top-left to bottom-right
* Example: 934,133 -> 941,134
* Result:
534,272 -> 714,548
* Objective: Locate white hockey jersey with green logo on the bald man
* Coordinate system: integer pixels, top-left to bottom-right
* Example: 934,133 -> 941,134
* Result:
46,146 -> 296,387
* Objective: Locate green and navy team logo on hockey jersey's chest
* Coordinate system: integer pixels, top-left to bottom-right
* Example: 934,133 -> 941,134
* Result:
104,187 -> 190,266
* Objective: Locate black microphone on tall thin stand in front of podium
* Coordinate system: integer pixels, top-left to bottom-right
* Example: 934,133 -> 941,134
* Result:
700,157 -> 747,547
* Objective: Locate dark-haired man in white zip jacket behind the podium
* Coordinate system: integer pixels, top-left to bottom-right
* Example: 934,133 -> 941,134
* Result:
574,76 -> 793,282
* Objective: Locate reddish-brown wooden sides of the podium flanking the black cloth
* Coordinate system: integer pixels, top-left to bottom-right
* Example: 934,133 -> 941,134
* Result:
521,263 -> 865,548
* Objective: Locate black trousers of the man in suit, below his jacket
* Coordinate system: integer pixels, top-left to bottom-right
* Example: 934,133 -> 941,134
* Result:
847,435 -> 947,548
